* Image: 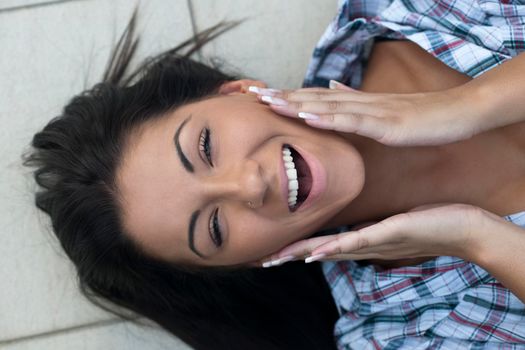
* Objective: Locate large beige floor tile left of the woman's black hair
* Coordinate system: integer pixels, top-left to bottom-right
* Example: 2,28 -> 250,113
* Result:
0,0 -> 192,340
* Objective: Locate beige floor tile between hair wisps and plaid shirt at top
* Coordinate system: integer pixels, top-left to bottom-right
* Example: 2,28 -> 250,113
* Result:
192,0 -> 337,88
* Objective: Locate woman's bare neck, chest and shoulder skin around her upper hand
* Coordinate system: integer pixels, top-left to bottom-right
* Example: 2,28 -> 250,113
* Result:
324,41 -> 525,228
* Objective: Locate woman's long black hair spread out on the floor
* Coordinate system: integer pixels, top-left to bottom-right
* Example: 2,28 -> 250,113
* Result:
23,10 -> 338,350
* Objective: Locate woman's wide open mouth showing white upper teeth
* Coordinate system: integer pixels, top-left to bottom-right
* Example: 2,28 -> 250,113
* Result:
283,144 -> 312,212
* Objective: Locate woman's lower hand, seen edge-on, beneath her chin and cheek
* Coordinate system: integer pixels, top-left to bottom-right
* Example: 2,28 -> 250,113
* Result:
261,203 -> 488,267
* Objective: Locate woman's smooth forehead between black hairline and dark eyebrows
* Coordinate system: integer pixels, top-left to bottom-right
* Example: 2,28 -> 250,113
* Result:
117,115 -> 185,260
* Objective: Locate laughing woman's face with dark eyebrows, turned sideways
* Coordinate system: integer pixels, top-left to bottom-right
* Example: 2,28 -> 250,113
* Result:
117,93 -> 364,266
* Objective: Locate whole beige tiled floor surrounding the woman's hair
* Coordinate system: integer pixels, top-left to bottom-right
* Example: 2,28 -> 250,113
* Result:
0,0 -> 337,350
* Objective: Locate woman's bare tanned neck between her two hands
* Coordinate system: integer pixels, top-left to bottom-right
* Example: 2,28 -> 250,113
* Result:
325,126 -> 523,228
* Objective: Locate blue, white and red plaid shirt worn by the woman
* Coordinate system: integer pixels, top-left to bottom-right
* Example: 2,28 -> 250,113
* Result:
303,0 -> 525,350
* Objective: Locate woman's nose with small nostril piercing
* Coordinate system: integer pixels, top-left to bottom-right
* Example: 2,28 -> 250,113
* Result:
205,159 -> 268,208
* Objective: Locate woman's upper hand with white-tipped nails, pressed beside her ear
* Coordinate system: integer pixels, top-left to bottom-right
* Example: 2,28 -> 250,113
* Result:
250,81 -> 487,146
